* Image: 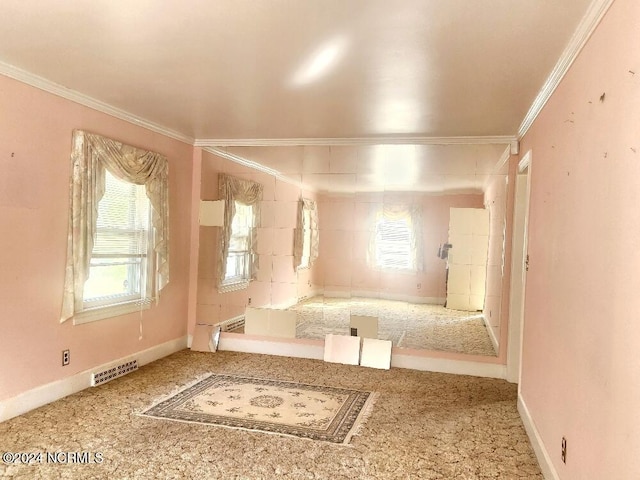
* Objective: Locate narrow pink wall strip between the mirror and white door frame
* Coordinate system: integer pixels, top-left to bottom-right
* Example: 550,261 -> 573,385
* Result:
507,150 -> 533,384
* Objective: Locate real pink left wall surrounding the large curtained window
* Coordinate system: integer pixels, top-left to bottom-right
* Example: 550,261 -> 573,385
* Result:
0,76 -> 192,400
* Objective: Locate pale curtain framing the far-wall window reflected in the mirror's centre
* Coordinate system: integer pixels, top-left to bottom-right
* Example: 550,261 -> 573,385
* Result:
367,204 -> 424,272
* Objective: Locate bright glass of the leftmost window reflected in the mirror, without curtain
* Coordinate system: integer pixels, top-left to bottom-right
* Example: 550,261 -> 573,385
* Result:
223,201 -> 253,285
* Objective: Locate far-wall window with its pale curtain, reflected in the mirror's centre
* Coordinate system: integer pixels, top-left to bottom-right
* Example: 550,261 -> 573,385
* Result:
368,205 -> 423,272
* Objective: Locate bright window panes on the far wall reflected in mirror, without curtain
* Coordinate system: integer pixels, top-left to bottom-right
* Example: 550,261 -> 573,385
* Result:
375,215 -> 415,270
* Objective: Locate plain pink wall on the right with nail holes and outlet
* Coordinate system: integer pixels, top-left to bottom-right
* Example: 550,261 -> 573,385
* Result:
521,0 -> 640,479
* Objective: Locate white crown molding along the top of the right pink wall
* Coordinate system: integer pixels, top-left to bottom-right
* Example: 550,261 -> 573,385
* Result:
518,0 -> 613,139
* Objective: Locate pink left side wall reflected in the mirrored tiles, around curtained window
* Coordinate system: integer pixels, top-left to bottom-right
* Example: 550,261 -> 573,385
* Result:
189,152 -> 315,332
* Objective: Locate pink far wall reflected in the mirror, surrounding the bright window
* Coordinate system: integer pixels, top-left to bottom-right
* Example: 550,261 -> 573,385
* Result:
317,193 -> 483,299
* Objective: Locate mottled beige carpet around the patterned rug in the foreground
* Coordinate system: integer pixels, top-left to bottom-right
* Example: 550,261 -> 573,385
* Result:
0,350 -> 542,480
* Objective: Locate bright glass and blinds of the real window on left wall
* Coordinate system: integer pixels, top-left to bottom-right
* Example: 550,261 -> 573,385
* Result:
83,171 -> 151,308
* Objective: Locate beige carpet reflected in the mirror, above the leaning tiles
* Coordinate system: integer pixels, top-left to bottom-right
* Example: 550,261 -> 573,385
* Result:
291,296 -> 496,356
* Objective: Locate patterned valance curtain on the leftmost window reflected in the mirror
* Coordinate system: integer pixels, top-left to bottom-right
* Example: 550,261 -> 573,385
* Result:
218,174 -> 263,290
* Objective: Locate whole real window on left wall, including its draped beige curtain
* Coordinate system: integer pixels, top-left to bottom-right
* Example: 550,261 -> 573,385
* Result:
60,130 -> 169,324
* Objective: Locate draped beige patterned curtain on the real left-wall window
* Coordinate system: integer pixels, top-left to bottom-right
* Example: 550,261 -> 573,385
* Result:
61,130 -> 169,322
